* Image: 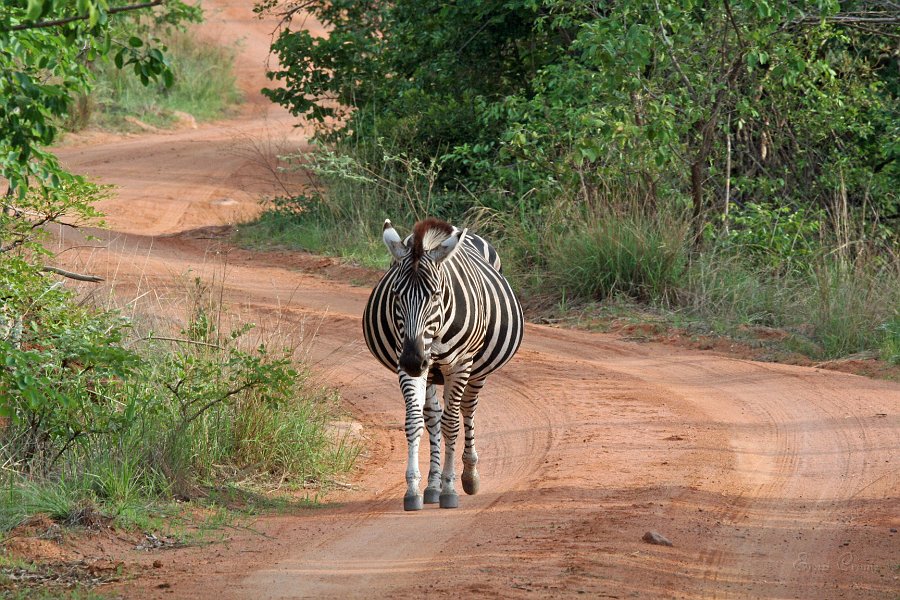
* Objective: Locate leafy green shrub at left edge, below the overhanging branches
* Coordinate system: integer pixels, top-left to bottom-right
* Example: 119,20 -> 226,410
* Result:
0,256 -> 138,474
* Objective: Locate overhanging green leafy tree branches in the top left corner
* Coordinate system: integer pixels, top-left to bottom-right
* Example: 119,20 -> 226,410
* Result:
0,0 -> 200,202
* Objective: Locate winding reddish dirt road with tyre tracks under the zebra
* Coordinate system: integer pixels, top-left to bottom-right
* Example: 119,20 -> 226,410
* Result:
51,0 -> 900,600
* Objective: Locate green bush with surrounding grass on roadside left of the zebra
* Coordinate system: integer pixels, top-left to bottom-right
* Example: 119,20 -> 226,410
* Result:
0,264 -> 356,525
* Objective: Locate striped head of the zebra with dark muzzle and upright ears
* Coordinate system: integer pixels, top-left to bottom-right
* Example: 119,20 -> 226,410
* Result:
383,219 -> 466,377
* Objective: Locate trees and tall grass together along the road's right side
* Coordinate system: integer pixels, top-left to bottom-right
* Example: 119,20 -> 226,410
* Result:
238,0 -> 900,363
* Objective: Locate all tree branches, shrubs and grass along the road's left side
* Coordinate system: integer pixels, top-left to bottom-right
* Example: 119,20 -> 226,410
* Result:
0,0 -> 358,580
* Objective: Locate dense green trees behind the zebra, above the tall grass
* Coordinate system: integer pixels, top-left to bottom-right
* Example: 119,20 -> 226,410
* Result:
257,0 -> 900,221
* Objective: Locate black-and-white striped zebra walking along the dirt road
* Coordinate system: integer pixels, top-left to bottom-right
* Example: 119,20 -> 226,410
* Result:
363,218 -> 524,511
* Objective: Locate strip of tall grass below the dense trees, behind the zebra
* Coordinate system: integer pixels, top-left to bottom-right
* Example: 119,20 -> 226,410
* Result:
238,143 -> 900,362
